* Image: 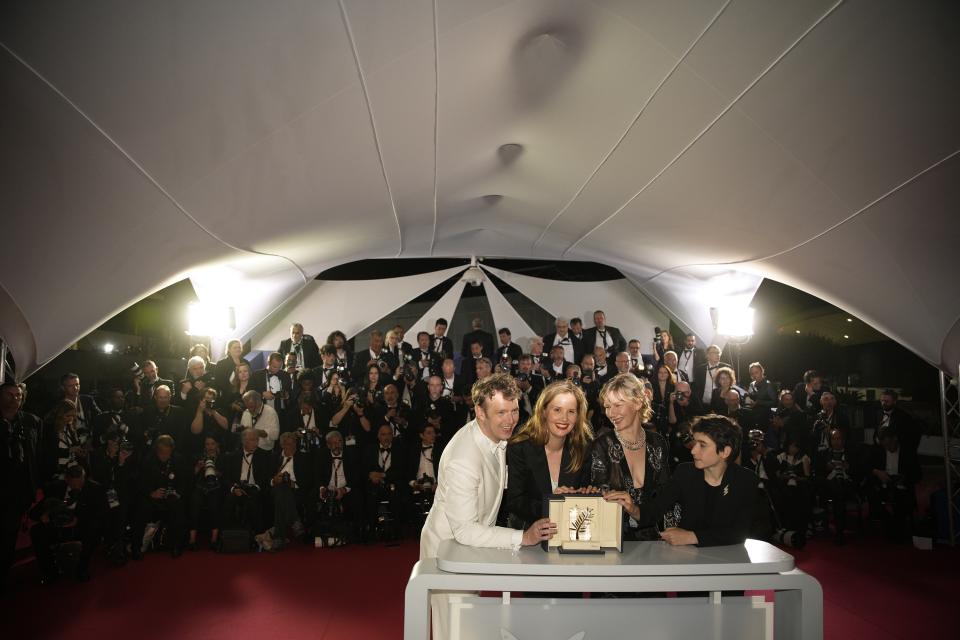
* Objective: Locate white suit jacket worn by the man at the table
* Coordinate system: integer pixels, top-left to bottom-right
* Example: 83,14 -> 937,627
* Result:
420,420 -> 523,560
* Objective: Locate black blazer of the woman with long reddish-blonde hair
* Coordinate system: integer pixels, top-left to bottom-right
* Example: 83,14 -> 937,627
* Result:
507,440 -> 589,529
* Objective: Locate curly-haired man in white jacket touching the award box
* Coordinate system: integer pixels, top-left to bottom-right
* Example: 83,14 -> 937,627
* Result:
420,373 -> 557,560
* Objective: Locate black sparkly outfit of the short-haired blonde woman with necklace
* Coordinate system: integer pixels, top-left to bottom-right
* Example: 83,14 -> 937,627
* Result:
588,430 -> 675,540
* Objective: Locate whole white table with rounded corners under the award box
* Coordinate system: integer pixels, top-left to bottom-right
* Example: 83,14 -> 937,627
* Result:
404,540 -> 823,640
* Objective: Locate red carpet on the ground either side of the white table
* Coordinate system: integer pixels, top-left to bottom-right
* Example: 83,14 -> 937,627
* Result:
0,538 -> 960,640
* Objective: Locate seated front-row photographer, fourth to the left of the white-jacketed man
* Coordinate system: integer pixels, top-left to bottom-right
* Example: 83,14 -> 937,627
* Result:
255,431 -> 317,551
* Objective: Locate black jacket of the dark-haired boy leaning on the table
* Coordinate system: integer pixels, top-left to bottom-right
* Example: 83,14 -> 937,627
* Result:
641,462 -> 757,547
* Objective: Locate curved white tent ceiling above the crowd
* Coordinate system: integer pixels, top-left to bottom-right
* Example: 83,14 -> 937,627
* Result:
0,0 -> 960,374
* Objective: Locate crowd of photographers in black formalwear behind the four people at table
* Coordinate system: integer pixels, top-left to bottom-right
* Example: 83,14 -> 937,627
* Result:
0,311 -> 919,582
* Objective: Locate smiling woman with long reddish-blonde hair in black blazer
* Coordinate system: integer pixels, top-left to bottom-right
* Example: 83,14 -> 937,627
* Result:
506,380 -> 593,529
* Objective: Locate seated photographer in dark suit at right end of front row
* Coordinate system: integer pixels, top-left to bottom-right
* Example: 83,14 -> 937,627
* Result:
866,430 -> 920,541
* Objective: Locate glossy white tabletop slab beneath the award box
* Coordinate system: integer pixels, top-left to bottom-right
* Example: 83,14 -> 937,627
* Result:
437,540 -> 794,576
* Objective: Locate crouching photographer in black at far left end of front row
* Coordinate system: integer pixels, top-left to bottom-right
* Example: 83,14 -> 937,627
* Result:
30,465 -> 107,584
